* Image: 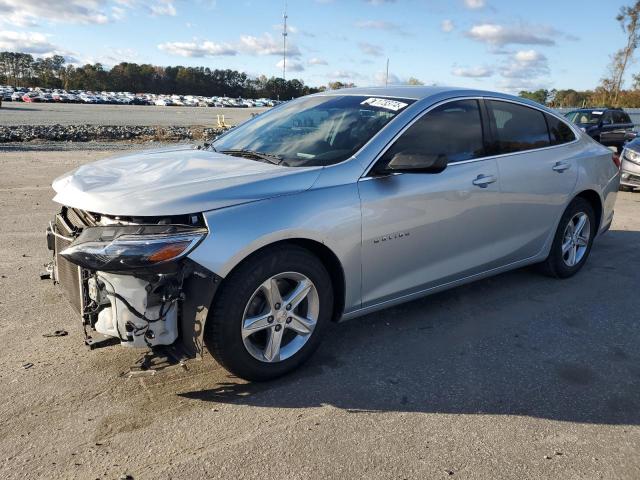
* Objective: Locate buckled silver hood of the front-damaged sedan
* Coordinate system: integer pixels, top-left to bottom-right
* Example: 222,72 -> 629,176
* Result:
53,147 -> 322,216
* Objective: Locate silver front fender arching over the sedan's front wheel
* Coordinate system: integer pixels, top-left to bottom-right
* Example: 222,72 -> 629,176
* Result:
189,183 -> 361,311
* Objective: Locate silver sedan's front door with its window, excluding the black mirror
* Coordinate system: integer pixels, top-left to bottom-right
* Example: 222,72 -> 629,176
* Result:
358,99 -> 504,308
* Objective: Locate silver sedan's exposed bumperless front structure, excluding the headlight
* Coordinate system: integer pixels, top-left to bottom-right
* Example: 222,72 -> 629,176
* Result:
47,208 -> 221,357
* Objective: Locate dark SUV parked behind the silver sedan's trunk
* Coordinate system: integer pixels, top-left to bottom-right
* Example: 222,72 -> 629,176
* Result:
565,108 -> 634,152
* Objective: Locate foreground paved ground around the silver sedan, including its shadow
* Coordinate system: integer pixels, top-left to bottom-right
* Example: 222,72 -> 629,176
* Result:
0,148 -> 640,480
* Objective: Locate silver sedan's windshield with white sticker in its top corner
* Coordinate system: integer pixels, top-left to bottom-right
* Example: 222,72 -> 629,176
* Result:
213,95 -> 414,167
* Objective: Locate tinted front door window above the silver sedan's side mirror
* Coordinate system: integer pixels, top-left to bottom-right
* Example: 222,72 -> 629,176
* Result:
384,100 -> 485,163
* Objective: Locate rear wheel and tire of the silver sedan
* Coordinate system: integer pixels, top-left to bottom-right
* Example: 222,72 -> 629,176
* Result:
540,197 -> 598,278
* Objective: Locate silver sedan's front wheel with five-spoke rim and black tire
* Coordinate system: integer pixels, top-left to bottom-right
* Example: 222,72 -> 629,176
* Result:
204,245 -> 333,381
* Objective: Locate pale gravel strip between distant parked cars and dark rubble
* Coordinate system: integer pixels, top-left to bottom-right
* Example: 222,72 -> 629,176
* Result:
0,102 -> 265,126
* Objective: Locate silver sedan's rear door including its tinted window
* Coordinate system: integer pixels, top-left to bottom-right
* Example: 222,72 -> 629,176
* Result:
486,100 -> 578,263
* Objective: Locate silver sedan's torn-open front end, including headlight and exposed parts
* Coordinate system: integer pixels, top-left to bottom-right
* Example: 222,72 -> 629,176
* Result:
47,207 -> 220,356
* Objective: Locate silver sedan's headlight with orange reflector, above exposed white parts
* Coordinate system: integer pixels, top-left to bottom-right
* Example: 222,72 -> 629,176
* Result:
60,225 -> 207,272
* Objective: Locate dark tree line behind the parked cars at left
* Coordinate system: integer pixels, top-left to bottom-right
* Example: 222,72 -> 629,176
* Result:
0,52 -> 320,100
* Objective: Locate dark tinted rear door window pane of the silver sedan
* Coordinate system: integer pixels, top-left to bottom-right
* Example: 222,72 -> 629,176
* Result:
487,100 -> 551,153
